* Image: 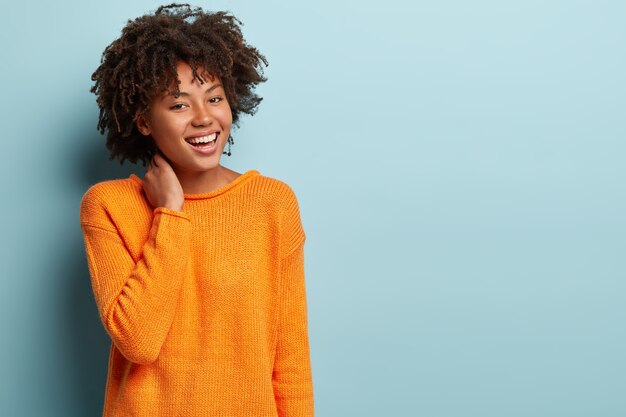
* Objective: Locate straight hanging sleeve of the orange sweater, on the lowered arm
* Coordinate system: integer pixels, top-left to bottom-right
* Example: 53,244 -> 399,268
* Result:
272,186 -> 314,417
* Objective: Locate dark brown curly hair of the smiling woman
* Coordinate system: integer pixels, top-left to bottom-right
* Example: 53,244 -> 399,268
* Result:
91,4 -> 267,165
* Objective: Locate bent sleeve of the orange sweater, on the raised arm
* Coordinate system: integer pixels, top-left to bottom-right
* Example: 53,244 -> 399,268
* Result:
81,208 -> 191,364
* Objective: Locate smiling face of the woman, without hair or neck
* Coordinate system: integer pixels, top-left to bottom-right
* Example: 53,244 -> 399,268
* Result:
136,62 -> 232,175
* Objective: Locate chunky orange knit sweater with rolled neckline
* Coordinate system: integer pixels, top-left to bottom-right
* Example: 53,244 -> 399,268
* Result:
81,170 -> 313,417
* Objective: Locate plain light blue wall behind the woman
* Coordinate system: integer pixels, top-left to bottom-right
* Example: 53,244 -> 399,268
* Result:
0,0 -> 626,417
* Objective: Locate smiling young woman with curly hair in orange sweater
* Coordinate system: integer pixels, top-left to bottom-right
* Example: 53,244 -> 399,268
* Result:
81,5 -> 313,417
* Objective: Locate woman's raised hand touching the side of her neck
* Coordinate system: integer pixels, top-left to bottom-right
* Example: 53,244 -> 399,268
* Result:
143,153 -> 185,211
